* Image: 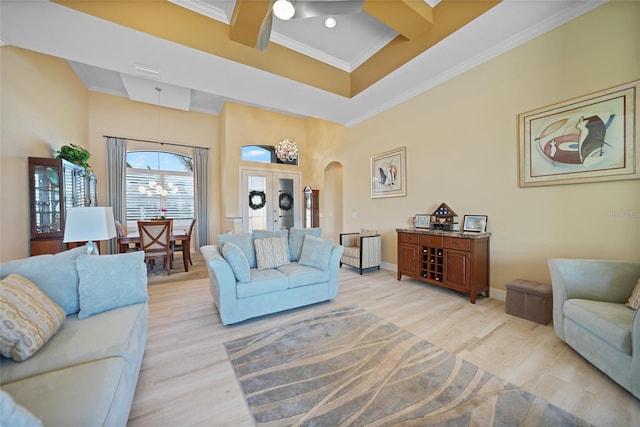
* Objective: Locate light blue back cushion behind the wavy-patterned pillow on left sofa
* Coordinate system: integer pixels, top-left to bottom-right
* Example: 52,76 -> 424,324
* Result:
0,246 -> 87,314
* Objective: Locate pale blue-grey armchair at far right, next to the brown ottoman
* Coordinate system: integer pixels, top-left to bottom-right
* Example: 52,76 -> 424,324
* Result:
548,259 -> 640,399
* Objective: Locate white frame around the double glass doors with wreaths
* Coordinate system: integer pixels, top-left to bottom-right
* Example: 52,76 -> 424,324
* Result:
238,167 -> 303,233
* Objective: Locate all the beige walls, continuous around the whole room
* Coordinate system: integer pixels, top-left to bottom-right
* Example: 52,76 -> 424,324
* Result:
0,2 -> 640,298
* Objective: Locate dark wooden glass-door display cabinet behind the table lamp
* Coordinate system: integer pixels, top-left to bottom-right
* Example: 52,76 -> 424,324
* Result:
29,157 -> 97,256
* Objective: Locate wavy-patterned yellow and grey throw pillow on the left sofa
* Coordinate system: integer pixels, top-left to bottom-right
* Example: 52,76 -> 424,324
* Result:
0,274 -> 67,362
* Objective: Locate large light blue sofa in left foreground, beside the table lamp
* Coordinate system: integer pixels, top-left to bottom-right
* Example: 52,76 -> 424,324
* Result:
0,247 -> 148,427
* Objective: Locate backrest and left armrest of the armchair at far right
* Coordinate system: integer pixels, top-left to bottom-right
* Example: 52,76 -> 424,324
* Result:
547,258 -> 640,340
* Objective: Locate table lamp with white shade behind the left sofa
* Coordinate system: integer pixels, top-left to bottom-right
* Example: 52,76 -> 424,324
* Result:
62,207 -> 116,255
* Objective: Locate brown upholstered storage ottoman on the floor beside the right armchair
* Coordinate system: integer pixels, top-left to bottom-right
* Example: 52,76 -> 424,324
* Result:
504,279 -> 553,325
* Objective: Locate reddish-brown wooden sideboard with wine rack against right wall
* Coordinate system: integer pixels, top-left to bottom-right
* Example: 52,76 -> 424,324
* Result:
396,229 -> 491,304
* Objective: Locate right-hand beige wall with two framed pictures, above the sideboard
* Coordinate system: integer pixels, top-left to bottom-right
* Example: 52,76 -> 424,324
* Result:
342,2 -> 640,289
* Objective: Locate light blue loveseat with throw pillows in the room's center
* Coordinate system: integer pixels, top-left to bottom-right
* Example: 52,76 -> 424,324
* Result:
200,228 -> 344,325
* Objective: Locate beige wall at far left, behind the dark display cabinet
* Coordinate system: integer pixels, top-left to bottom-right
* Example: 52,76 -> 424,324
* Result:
0,46 -> 89,260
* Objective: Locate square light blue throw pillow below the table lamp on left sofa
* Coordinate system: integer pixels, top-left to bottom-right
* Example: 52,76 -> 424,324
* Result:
76,251 -> 149,320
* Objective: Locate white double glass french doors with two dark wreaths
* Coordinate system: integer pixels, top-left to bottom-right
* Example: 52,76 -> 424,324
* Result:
240,168 -> 302,232
